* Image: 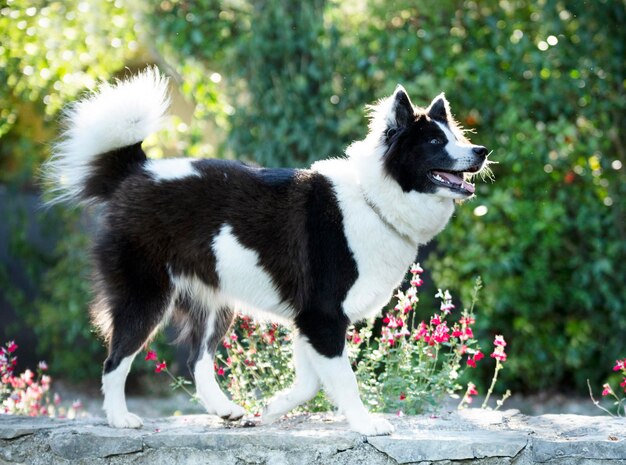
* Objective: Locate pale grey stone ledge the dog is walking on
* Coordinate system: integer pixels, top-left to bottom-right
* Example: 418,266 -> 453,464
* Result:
0,409 -> 626,465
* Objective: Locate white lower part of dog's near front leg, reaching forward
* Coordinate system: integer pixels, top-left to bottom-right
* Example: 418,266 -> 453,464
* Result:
303,344 -> 393,436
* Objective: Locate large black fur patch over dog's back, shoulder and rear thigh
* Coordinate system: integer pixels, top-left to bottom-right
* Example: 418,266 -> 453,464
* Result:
94,160 -> 358,371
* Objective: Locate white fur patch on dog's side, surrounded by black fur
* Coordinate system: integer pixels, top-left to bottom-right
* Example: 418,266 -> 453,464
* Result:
213,224 -> 293,320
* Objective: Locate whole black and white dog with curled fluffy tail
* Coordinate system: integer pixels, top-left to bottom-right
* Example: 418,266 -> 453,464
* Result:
44,69 -> 487,435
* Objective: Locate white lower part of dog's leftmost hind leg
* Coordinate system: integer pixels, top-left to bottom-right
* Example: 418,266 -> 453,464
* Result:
102,354 -> 143,428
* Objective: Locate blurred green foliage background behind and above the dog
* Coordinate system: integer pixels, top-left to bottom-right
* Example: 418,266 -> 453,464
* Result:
0,0 -> 626,406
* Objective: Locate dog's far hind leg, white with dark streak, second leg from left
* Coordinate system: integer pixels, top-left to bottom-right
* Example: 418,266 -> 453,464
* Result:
189,308 -> 246,420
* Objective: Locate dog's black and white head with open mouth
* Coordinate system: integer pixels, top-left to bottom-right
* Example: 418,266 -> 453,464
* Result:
370,86 -> 488,199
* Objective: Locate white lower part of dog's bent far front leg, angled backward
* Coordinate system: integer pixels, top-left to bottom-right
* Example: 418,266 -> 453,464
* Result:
262,335 -> 320,424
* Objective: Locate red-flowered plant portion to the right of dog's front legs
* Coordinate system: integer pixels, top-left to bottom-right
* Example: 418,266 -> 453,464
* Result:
349,264 -> 510,414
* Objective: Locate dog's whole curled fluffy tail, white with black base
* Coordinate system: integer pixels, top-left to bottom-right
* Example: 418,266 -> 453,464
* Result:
43,67 -> 170,203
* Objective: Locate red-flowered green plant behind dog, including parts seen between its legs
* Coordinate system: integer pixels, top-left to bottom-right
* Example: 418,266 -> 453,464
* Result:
146,264 -> 510,413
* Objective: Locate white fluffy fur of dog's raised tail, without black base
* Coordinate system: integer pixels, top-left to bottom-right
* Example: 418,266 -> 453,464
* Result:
44,67 -> 170,203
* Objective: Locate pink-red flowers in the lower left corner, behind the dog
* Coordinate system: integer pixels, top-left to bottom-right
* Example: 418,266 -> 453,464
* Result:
0,341 -> 82,418
